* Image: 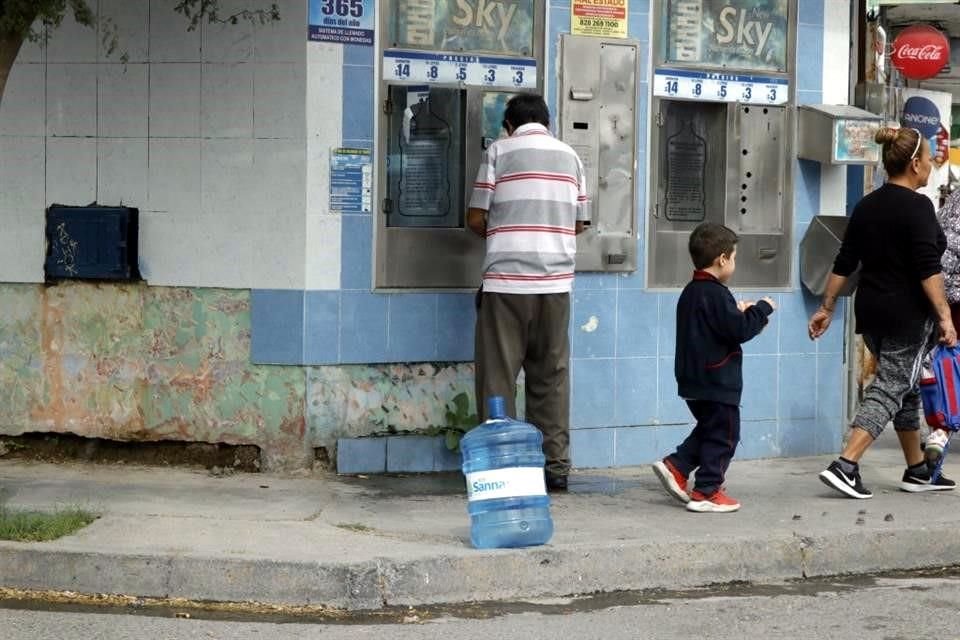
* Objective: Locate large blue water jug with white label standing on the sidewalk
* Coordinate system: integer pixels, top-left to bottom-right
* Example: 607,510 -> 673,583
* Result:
460,396 -> 553,549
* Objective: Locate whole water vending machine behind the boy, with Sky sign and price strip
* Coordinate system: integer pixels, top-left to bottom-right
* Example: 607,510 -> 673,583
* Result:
647,0 -> 796,287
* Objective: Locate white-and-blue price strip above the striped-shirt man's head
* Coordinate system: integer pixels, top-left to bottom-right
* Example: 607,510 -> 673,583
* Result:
383,50 -> 537,89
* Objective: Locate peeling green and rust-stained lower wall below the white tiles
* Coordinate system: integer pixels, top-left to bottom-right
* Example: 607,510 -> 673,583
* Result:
0,282 -> 492,468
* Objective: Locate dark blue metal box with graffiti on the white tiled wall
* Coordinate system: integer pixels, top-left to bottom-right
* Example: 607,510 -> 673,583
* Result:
44,204 -> 140,280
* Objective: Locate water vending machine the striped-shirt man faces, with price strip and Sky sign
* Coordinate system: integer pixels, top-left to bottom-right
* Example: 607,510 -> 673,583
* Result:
375,0 -> 545,288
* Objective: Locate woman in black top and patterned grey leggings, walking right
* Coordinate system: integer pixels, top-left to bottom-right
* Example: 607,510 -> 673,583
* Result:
808,128 -> 957,499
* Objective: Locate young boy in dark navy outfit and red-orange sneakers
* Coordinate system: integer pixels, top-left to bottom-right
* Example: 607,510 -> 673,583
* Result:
653,222 -> 776,513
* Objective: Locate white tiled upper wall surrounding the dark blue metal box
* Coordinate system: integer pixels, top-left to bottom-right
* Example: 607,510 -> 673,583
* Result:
0,0 -> 308,289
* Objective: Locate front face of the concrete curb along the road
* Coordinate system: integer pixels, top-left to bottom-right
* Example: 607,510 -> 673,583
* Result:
7,528 -> 960,610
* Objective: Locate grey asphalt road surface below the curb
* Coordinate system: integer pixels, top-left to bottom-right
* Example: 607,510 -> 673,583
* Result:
0,574 -> 960,640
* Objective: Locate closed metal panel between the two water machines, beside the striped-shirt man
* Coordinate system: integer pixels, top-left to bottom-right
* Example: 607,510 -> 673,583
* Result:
559,34 -> 640,272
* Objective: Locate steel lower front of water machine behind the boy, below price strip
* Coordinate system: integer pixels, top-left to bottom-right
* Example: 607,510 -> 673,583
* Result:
649,100 -> 791,287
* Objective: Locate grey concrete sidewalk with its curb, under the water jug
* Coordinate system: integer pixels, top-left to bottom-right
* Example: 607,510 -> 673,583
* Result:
0,433 -> 960,609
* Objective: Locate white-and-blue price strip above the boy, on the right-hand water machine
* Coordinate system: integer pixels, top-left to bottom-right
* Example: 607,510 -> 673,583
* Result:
653,69 -> 790,104
